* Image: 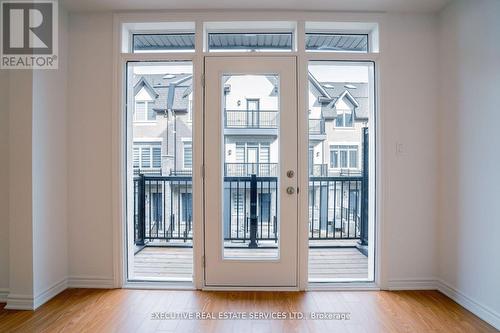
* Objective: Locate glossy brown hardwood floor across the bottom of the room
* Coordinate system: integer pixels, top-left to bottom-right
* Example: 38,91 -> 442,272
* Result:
0,289 -> 496,333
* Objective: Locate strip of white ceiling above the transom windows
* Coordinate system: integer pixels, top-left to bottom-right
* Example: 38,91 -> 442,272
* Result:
62,0 -> 451,12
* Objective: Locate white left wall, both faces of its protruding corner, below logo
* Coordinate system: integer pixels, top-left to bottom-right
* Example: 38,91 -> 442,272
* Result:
0,8 -> 68,309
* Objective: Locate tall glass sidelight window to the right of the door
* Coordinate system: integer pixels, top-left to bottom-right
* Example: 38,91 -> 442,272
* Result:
308,61 -> 375,283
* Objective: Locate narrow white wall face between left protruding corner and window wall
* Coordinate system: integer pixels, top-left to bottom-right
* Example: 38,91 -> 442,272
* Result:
33,8 -> 68,306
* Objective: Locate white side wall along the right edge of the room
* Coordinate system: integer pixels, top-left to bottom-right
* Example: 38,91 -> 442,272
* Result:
438,0 -> 500,329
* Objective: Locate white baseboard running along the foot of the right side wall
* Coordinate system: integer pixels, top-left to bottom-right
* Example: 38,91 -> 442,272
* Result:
436,280 -> 500,330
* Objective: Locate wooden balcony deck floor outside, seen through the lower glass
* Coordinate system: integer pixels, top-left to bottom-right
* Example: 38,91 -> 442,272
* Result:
133,247 -> 368,281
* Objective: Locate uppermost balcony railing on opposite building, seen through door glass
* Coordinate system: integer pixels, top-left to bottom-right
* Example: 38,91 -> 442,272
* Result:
224,110 -> 278,129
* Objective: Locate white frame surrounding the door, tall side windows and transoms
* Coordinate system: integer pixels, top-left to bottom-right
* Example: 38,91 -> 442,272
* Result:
110,11 -> 380,290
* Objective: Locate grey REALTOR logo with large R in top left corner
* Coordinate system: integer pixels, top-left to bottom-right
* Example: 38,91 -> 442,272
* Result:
1,0 -> 57,69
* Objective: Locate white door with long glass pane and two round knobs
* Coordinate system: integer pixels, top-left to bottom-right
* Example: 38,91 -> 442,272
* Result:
204,56 -> 298,287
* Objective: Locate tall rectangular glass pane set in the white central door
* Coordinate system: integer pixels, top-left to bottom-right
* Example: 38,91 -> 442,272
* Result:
220,74 -> 280,259
